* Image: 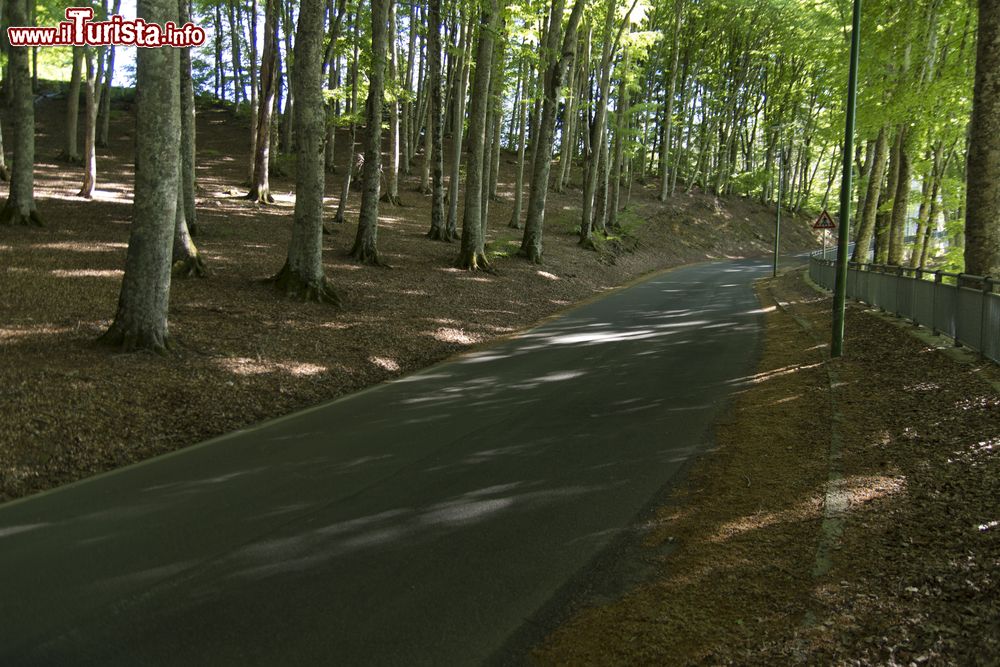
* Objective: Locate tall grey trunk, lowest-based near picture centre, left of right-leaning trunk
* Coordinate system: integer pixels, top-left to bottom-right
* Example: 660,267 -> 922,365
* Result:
456,0 -> 497,271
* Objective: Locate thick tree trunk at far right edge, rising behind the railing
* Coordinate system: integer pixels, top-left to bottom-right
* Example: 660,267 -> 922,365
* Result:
965,0 -> 1000,277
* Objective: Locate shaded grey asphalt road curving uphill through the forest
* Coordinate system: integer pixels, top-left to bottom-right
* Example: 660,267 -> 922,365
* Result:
0,261 -> 770,666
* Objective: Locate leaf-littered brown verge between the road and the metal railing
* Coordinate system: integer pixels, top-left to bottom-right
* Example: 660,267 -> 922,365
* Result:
533,270 -> 1000,665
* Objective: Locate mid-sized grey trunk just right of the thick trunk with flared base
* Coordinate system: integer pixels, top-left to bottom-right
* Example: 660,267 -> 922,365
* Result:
351,0 -> 393,266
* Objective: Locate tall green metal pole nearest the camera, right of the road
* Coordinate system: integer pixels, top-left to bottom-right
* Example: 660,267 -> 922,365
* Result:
830,0 -> 861,357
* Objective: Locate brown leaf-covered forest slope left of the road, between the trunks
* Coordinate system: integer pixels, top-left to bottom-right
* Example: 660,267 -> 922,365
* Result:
0,88 -> 816,501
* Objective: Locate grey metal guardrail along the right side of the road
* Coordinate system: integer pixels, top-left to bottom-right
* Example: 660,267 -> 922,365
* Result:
809,255 -> 1000,363
